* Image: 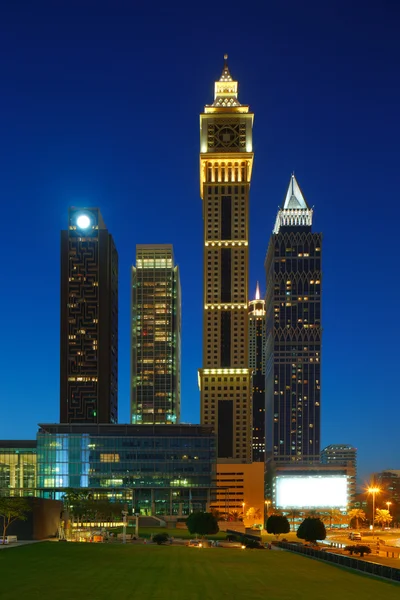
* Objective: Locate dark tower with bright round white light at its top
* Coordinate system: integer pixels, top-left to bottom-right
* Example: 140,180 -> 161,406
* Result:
60,208 -> 118,423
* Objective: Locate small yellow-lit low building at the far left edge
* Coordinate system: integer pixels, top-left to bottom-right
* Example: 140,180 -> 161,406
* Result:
0,440 -> 36,496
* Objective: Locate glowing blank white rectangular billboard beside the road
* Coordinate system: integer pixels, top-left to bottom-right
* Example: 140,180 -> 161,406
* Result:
275,475 -> 347,508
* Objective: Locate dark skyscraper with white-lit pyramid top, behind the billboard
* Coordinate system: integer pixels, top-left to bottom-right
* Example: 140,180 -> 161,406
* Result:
265,175 -> 322,462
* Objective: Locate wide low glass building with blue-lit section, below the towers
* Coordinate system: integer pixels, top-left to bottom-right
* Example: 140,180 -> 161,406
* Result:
37,424 -> 216,515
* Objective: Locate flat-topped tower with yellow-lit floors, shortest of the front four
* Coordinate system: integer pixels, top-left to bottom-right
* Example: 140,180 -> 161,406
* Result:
131,244 -> 181,424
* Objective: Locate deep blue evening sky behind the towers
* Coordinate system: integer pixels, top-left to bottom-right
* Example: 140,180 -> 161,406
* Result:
0,0 -> 400,479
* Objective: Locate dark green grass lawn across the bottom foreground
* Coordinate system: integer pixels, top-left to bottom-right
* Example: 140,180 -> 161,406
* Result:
0,542 -> 400,600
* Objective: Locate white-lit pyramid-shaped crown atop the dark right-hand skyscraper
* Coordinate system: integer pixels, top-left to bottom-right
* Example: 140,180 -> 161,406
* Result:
274,173 -> 313,233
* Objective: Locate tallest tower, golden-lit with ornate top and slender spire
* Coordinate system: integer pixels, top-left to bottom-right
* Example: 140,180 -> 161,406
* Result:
199,57 -> 254,462
